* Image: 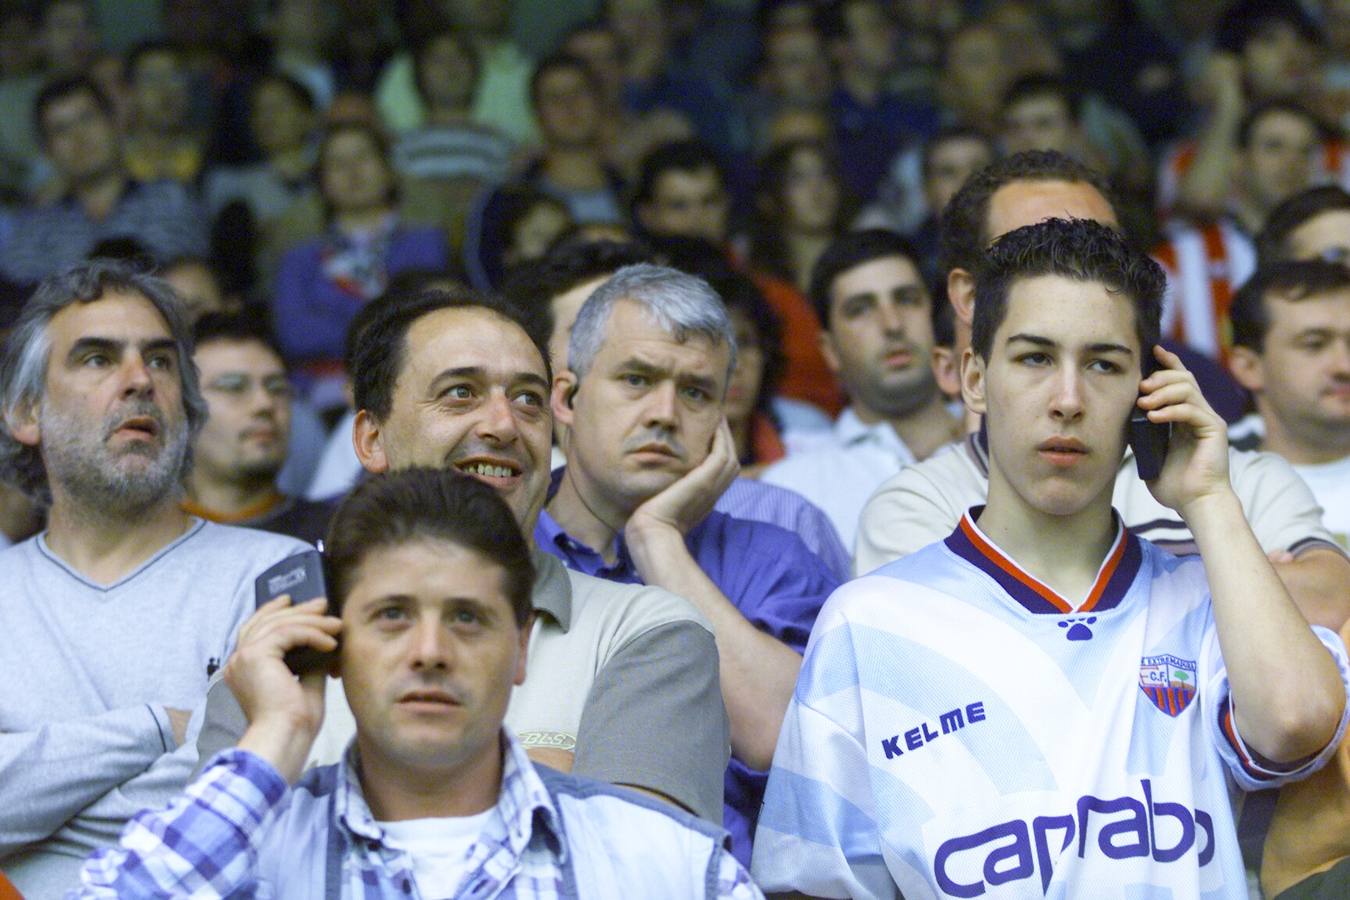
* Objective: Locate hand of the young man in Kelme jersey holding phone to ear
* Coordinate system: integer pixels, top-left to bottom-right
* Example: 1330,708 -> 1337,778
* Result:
1137,347 -> 1233,522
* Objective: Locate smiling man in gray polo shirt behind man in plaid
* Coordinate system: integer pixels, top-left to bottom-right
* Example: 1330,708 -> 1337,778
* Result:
198,284 -> 730,823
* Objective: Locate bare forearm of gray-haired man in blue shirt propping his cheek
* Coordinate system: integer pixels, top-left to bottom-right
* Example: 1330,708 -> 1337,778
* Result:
629,534 -> 802,769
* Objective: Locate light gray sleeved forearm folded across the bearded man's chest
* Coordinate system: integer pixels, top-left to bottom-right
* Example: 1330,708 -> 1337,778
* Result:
0,704 -> 174,861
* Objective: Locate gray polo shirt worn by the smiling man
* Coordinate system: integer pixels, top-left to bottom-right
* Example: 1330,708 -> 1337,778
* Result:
197,551 -> 730,824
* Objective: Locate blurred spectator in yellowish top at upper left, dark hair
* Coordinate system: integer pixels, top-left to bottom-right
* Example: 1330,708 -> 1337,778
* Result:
123,40 -> 204,185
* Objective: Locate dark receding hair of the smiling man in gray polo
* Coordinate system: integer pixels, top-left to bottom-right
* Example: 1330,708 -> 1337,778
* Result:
348,287 -> 552,421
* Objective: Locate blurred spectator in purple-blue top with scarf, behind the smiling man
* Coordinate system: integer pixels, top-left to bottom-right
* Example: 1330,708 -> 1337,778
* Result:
273,123 -> 448,407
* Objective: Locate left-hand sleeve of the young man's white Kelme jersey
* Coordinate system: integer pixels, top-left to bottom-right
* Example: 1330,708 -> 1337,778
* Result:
751,583 -> 899,899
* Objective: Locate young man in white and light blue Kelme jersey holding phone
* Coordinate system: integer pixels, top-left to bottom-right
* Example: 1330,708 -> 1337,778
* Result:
753,220 -> 1347,900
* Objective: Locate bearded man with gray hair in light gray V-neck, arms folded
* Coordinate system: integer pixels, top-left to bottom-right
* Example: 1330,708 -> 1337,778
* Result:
0,260 -> 304,900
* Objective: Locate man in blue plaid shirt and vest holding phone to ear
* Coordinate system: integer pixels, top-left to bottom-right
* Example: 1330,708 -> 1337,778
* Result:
70,468 -> 763,900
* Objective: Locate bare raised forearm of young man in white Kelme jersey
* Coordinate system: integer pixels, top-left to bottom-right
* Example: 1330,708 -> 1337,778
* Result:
1185,491 -> 1346,762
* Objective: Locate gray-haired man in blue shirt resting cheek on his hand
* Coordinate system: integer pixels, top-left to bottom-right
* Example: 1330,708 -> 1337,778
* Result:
535,263 -> 837,860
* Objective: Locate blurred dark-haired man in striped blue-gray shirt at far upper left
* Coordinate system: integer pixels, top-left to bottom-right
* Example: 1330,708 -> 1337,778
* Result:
0,77 -> 207,283
